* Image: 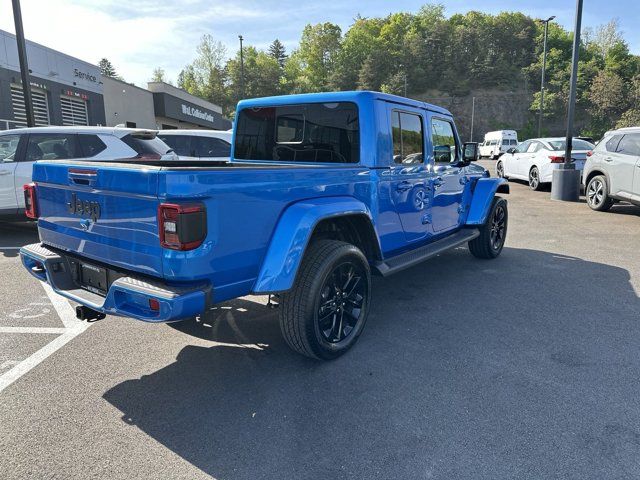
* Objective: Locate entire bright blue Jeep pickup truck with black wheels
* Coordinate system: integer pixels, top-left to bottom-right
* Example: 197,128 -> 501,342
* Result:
20,92 -> 509,359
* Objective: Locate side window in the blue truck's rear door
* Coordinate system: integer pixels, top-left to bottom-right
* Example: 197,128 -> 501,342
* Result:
391,111 -> 424,164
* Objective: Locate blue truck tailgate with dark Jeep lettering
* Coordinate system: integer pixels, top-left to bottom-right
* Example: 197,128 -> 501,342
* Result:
33,162 -> 163,277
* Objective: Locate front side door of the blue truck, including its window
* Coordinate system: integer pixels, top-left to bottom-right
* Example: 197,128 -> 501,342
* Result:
430,117 -> 467,233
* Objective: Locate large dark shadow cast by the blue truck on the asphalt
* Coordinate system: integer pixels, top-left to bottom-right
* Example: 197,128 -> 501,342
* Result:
104,248 -> 640,479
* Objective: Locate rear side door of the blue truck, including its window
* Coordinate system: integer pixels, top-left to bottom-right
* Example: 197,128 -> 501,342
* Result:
385,107 -> 431,242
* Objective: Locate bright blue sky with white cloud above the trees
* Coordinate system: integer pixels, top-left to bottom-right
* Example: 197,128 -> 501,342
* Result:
0,0 -> 640,86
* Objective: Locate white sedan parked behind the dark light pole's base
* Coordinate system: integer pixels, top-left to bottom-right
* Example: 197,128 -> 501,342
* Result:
496,137 -> 594,190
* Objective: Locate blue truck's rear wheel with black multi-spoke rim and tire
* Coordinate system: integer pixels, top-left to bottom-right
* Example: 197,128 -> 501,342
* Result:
280,240 -> 371,360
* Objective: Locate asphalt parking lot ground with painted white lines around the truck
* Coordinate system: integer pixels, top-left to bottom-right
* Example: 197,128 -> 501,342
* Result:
0,162 -> 640,479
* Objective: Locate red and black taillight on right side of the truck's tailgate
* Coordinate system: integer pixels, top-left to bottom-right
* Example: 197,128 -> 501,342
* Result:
158,203 -> 207,250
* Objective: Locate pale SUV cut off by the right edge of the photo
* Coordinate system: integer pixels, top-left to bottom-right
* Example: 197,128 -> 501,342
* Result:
583,127 -> 640,212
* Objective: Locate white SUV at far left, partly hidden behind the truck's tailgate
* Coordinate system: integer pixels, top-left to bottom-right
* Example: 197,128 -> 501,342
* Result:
0,127 -> 178,216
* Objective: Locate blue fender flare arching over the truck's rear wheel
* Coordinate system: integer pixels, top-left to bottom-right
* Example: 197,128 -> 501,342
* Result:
253,197 -> 379,294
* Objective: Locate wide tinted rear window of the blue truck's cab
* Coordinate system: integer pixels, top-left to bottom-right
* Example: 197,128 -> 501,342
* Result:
235,102 -> 360,163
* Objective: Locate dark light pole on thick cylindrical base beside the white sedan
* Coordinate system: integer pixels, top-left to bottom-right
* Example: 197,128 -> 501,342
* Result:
551,0 -> 582,202
